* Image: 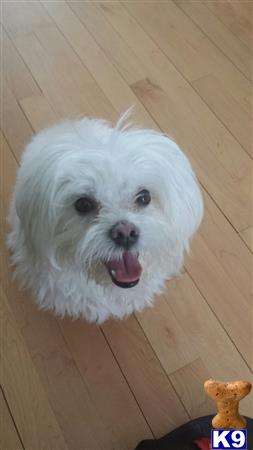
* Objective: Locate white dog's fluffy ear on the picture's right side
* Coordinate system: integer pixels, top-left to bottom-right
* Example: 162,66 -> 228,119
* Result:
120,129 -> 203,248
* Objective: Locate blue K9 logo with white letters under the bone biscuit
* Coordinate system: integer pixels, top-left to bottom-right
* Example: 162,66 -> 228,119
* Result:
212,430 -> 247,450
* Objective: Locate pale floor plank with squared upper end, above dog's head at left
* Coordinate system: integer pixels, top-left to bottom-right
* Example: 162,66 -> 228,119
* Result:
14,27 -> 116,120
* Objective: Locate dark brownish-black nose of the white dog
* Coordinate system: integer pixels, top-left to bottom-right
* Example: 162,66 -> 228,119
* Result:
109,222 -> 139,249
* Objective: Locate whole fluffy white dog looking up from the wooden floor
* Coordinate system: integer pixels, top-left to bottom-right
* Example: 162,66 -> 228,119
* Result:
8,115 -> 203,323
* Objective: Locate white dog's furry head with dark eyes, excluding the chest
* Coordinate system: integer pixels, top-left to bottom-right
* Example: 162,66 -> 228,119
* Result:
17,120 -> 202,288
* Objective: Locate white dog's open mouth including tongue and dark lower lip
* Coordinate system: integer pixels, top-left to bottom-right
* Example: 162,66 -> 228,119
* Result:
105,250 -> 142,288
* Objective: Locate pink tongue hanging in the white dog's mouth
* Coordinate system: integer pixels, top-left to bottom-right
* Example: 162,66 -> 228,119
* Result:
107,251 -> 142,283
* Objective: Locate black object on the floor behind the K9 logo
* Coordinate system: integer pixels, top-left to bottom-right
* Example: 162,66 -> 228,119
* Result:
135,416 -> 253,450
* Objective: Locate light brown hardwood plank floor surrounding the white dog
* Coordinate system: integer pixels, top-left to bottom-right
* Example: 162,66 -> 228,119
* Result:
0,0 -> 253,450
